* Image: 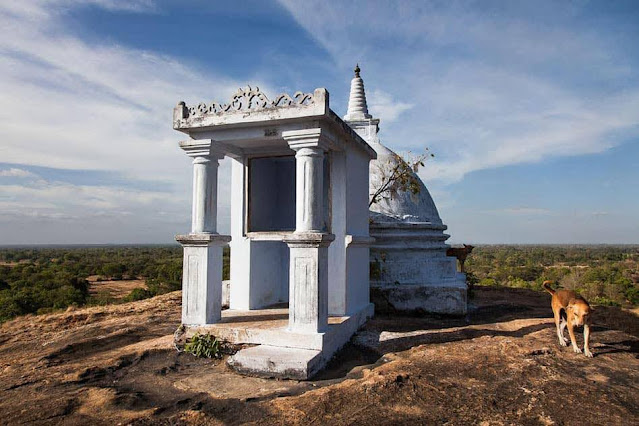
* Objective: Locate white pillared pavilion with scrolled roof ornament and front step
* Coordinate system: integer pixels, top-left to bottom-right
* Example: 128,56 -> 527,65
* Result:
173,87 -> 376,379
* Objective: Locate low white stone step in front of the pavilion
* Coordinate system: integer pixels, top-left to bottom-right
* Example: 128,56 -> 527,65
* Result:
228,345 -> 326,380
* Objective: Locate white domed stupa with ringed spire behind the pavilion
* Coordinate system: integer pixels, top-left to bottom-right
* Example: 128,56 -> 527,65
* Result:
344,66 -> 467,315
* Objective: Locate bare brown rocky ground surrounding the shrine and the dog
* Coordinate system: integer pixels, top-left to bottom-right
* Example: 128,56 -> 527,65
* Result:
0,288 -> 639,425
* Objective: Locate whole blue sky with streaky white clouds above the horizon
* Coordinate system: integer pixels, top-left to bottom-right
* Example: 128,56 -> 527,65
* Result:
0,0 -> 639,245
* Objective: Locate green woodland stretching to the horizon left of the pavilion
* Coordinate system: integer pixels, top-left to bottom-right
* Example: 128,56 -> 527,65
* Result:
0,246 -> 229,321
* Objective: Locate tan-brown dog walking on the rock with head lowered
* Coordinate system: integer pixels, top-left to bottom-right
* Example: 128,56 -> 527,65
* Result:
543,281 -> 593,358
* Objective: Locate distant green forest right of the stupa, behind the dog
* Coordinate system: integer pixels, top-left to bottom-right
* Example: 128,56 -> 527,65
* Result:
466,246 -> 639,306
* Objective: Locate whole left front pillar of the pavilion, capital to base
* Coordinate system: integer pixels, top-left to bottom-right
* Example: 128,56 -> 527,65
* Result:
175,140 -> 231,325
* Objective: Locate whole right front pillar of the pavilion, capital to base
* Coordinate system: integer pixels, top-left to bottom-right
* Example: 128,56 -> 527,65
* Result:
282,129 -> 335,333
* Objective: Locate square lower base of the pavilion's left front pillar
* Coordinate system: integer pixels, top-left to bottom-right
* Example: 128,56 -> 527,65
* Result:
175,234 -> 231,325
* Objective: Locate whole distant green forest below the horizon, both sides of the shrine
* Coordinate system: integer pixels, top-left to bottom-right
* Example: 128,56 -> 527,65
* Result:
0,245 -> 639,321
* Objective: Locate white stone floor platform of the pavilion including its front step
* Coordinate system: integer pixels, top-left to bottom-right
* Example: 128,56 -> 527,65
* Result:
186,303 -> 374,380
